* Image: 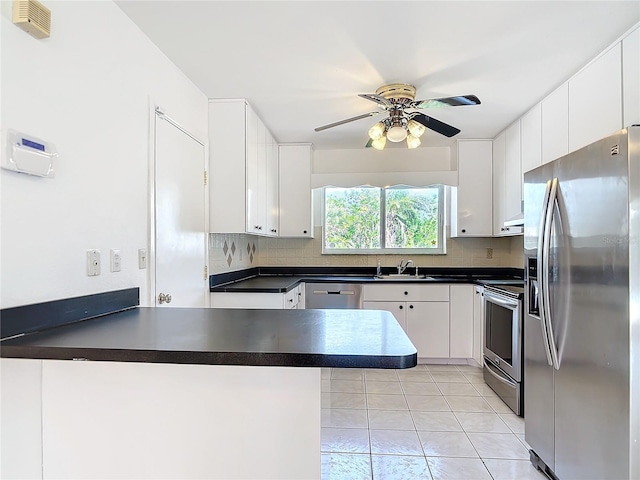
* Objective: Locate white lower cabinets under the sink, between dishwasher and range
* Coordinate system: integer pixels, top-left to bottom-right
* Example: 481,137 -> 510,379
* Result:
363,284 -> 475,359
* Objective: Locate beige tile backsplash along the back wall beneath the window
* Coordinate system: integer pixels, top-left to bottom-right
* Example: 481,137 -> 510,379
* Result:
209,227 -> 524,273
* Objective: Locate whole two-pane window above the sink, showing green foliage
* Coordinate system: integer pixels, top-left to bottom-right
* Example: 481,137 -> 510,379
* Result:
322,185 -> 445,254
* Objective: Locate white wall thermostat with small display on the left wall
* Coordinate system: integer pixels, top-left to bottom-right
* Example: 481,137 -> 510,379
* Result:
1,130 -> 58,178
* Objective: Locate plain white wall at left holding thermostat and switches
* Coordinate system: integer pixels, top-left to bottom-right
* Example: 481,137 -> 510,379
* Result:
0,0 -> 207,308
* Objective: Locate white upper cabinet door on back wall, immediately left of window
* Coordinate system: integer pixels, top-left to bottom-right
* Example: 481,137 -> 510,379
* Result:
278,144 -> 313,238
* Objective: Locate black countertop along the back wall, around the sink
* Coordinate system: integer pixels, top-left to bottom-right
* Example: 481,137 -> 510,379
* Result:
210,267 -> 523,293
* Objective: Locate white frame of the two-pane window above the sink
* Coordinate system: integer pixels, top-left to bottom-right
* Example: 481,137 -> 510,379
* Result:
321,185 -> 447,255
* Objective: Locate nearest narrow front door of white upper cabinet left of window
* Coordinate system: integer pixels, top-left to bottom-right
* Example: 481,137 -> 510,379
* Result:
248,105 -> 261,234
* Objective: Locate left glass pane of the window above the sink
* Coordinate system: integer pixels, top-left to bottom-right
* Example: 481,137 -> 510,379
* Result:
324,187 -> 380,250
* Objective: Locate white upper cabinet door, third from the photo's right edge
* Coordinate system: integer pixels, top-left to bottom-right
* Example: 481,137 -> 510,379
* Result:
540,83 -> 569,164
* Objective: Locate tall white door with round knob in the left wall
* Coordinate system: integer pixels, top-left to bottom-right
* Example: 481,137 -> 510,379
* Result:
152,112 -> 208,307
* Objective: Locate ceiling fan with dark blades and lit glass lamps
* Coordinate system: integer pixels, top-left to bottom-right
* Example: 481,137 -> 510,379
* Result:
315,83 -> 480,150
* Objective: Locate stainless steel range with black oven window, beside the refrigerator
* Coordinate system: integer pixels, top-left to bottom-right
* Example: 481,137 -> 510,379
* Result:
483,282 -> 524,416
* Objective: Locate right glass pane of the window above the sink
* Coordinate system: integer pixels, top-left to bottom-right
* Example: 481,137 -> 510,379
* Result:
385,187 -> 440,248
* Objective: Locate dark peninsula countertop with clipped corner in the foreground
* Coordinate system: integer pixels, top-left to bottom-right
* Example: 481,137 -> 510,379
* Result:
0,307 -> 417,368
